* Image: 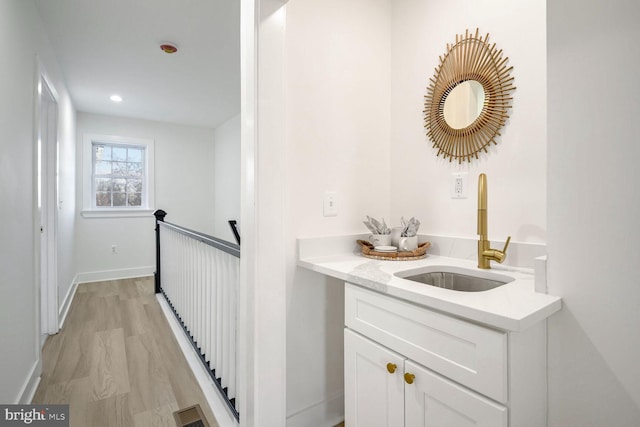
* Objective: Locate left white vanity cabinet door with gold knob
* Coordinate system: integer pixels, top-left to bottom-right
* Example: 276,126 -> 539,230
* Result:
344,329 -> 404,427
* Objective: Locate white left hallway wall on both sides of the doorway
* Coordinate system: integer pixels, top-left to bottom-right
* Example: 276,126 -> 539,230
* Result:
0,0 -> 75,403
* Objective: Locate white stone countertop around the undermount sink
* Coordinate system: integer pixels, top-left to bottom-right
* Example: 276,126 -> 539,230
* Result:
298,236 -> 562,331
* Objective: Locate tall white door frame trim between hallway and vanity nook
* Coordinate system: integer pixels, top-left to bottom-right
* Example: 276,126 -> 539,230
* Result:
238,0 -> 288,427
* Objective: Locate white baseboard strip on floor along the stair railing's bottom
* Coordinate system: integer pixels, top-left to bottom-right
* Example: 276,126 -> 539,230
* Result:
156,294 -> 239,427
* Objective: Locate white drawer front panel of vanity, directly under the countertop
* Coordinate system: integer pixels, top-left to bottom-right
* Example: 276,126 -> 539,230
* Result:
345,284 -> 507,402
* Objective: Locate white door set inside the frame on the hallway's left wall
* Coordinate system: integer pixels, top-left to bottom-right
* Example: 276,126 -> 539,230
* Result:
37,73 -> 58,334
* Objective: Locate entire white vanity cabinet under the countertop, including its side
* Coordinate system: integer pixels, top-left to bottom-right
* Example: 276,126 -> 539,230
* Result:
345,284 -> 546,427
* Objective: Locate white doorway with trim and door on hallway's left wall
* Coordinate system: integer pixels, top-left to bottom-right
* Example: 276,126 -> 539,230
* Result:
34,57 -> 59,338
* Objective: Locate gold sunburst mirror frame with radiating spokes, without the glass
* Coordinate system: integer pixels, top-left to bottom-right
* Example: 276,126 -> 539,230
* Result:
424,29 -> 515,163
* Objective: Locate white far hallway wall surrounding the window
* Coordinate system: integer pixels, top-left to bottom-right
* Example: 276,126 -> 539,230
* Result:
76,113 -> 214,280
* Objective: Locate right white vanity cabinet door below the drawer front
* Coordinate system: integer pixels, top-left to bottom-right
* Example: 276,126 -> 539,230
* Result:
408,360 -> 509,427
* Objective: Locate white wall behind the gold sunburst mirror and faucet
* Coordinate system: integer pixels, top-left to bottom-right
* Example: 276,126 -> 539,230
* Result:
388,0 -> 547,243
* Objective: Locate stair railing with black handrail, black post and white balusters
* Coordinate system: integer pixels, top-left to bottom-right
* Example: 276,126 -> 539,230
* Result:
154,210 -> 240,420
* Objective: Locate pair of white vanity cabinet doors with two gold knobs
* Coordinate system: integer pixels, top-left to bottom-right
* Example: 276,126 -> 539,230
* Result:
344,329 -> 507,427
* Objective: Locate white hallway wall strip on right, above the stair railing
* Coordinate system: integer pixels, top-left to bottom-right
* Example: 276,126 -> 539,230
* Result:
209,114 -> 240,243
